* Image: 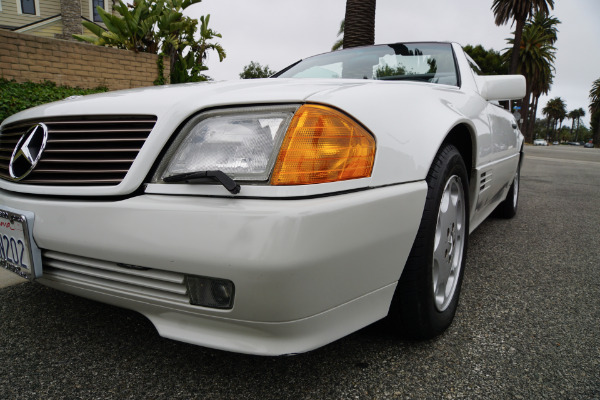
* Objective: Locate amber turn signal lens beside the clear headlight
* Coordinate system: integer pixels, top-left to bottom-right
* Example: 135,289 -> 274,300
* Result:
271,105 -> 375,185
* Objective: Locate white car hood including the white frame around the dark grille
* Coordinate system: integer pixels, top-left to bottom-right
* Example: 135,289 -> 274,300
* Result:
0,79 -> 384,196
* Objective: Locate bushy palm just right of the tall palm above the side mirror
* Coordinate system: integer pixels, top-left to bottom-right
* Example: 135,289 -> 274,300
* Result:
504,13 -> 560,142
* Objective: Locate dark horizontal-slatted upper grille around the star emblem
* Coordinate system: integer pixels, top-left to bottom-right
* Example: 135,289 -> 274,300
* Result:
0,116 -> 156,186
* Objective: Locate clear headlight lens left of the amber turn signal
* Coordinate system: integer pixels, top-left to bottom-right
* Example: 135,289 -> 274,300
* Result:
157,106 -> 298,181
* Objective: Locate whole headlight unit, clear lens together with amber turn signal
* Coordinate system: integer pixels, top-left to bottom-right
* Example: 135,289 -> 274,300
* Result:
153,105 -> 375,185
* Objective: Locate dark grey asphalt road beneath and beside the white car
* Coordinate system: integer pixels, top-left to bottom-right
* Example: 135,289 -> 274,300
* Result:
0,146 -> 600,399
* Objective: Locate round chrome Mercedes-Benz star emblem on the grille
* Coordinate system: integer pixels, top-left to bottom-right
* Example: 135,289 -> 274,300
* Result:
8,123 -> 48,181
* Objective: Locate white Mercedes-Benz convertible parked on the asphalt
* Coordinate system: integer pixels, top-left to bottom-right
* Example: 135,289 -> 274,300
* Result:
0,43 -> 525,355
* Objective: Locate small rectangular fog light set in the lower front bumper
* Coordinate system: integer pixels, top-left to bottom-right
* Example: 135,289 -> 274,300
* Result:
185,275 -> 235,309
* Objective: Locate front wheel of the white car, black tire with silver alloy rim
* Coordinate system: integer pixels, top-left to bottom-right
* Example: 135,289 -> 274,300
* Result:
390,144 -> 469,339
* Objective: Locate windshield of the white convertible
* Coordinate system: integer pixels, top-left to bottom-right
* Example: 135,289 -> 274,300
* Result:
274,43 -> 458,86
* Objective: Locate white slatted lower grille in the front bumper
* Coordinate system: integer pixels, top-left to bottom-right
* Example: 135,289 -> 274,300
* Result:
42,250 -> 189,305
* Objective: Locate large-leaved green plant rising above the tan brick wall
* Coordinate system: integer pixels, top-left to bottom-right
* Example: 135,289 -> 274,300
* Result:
73,0 -> 226,83
